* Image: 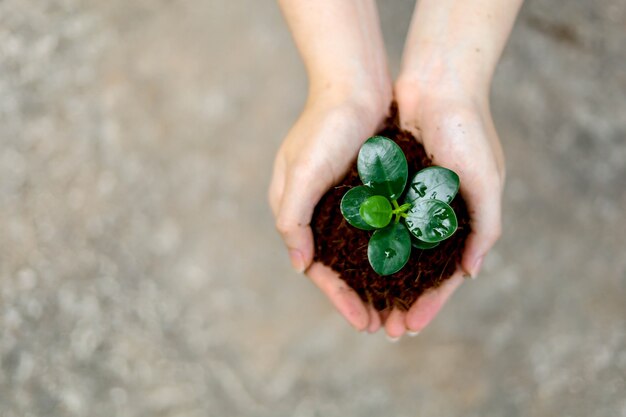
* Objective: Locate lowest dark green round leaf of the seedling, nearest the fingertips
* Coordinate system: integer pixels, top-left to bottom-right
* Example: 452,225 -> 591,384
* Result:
367,223 -> 411,275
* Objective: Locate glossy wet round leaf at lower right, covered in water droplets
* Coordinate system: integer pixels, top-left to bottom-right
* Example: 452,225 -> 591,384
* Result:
404,200 -> 458,243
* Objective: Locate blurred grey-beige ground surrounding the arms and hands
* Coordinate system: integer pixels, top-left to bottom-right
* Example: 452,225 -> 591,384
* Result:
0,0 -> 626,417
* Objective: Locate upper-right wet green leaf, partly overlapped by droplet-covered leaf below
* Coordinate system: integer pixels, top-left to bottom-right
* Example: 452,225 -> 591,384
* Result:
404,166 -> 459,204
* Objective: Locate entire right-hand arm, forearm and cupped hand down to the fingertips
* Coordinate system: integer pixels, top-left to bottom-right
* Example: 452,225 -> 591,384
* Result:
378,0 -> 522,338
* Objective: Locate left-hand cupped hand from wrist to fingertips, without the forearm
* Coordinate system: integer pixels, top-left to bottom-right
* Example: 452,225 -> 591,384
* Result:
269,90 -> 391,332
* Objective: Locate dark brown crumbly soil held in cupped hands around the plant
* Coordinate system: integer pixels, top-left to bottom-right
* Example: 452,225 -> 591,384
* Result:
311,104 -> 470,311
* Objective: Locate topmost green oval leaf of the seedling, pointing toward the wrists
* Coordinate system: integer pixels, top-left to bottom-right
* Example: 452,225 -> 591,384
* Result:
357,136 -> 409,200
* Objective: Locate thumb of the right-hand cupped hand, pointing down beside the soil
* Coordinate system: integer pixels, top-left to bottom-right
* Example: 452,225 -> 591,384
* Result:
461,172 -> 502,277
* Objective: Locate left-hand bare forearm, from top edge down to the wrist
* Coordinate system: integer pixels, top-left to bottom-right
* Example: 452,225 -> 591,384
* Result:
279,0 -> 391,106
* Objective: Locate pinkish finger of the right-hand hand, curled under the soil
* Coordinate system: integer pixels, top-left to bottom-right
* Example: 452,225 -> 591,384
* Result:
403,271 -> 463,332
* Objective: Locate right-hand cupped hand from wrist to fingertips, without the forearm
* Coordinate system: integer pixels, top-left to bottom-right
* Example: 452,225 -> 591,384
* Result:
385,75 -> 505,339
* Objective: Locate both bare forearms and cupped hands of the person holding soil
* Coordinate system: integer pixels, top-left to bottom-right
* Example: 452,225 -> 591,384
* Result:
269,0 -> 521,340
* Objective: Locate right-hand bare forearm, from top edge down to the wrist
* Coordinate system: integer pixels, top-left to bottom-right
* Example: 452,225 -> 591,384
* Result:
400,0 -> 522,94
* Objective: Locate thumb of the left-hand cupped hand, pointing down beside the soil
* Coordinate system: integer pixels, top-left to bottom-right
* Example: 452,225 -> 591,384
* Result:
276,168 -> 326,272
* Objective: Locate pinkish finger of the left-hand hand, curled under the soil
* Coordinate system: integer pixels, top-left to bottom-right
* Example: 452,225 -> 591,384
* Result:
307,262 -> 370,331
